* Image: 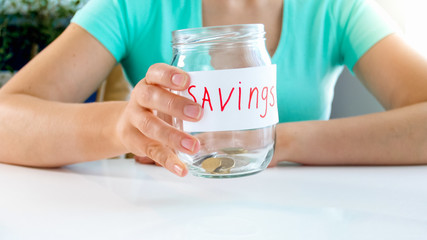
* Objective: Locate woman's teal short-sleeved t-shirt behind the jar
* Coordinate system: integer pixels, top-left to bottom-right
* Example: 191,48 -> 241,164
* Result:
72,0 -> 395,122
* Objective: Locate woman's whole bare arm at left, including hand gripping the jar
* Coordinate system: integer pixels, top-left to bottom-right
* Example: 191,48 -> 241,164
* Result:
0,24 -> 201,176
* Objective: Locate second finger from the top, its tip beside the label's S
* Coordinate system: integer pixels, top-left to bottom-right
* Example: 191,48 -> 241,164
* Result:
131,84 -> 203,122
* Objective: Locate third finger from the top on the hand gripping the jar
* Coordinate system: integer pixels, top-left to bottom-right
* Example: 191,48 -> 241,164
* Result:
130,109 -> 200,155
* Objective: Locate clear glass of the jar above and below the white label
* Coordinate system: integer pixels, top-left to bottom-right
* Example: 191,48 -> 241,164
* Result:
172,24 -> 275,178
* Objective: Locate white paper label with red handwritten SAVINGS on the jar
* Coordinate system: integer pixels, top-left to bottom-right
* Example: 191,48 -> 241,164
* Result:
181,65 -> 279,132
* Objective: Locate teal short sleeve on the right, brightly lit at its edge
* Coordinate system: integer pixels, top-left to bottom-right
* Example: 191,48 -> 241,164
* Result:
334,0 -> 398,73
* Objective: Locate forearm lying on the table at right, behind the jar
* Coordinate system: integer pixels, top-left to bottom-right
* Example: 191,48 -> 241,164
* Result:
274,103 -> 427,165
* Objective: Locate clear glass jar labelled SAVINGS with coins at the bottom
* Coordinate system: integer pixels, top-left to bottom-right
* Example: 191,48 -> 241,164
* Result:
171,24 -> 278,178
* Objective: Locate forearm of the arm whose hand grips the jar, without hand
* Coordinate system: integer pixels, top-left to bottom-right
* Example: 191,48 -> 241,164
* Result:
0,95 -> 126,167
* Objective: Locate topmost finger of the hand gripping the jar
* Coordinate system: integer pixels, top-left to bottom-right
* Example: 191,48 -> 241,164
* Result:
145,63 -> 190,90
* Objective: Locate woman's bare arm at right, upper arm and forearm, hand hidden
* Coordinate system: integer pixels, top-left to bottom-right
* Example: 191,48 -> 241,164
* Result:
272,35 -> 427,165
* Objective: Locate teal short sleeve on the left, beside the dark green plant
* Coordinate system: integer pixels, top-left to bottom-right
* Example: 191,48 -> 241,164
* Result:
71,0 -> 129,62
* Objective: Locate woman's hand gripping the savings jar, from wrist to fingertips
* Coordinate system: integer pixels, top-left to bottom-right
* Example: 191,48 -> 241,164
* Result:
117,64 -> 202,176
